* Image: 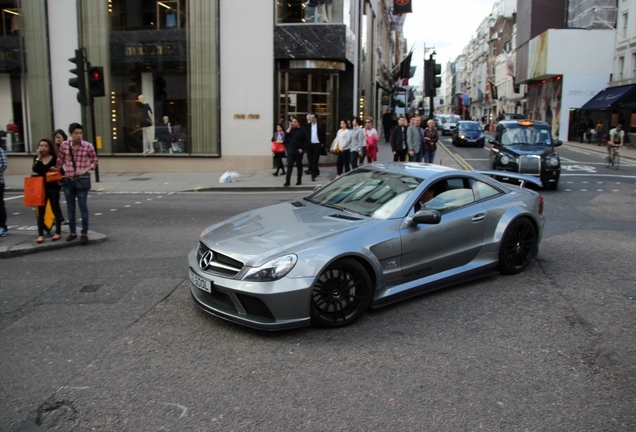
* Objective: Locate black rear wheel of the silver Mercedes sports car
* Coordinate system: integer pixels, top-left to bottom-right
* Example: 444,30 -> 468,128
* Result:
497,218 -> 537,274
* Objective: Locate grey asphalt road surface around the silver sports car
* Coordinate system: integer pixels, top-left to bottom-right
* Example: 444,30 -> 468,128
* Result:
0,176 -> 636,431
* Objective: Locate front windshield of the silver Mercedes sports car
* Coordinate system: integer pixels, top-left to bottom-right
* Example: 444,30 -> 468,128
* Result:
305,169 -> 422,219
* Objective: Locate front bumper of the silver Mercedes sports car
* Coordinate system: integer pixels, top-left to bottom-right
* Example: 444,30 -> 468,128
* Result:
188,248 -> 313,330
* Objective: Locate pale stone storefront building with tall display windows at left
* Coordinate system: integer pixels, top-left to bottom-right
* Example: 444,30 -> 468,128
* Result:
0,0 -> 401,176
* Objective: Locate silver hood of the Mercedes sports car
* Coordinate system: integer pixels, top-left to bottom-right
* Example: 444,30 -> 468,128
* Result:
201,200 -> 376,266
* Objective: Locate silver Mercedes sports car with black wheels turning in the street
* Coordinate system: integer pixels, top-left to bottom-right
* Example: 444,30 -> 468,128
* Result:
188,162 -> 544,330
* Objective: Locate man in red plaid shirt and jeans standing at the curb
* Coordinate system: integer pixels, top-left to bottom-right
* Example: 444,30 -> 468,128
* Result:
56,123 -> 97,245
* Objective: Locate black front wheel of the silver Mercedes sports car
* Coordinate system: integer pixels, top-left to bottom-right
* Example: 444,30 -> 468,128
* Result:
310,258 -> 373,328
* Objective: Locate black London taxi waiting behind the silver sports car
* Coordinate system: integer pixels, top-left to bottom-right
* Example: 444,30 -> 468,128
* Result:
488,120 -> 563,190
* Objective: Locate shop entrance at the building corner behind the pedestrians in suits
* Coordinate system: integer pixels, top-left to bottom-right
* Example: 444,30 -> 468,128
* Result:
278,70 -> 339,143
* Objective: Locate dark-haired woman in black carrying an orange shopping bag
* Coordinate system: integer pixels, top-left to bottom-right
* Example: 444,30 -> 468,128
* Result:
32,138 -> 62,243
